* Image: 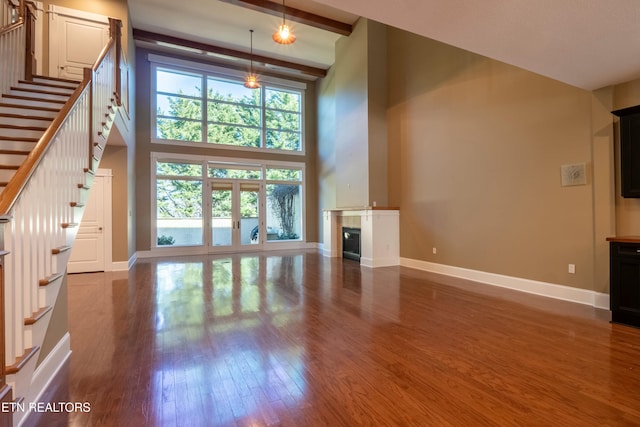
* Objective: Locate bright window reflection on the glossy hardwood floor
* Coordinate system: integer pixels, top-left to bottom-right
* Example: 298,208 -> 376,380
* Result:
151,255 -> 306,424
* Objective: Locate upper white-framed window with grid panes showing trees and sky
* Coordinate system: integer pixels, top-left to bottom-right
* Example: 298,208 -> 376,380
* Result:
152,64 -> 304,152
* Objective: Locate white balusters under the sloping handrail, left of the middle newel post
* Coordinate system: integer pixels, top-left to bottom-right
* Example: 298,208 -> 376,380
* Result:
4,87 -> 90,365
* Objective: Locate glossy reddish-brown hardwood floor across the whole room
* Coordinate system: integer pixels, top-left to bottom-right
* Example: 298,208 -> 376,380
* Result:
27,252 -> 640,427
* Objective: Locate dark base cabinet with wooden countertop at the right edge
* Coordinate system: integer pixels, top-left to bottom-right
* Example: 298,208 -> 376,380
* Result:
610,240 -> 640,327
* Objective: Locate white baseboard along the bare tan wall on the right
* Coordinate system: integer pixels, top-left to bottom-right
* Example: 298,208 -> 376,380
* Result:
400,257 -> 609,310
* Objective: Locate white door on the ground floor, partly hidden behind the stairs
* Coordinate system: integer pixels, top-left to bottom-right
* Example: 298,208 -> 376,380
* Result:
67,176 -> 105,273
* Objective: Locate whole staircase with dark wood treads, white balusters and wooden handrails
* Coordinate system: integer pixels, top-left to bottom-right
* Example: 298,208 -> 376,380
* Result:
0,0 -> 126,426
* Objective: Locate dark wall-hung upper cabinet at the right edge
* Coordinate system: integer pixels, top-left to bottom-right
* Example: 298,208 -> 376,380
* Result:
612,105 -> 640,198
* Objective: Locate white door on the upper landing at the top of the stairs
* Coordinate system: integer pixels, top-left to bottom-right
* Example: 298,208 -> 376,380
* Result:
49,6 -> 109,80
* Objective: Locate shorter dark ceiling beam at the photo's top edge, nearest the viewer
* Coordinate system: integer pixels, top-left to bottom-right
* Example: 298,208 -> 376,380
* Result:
221,0 -> 353,36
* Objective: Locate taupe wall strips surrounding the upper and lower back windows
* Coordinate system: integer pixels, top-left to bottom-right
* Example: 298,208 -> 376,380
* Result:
135,48 -> 318,251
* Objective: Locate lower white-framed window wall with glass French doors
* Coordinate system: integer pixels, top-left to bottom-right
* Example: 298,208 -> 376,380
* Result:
152,153 -> 304,249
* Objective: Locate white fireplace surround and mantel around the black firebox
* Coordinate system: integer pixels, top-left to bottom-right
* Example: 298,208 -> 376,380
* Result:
322,207 -> 400,267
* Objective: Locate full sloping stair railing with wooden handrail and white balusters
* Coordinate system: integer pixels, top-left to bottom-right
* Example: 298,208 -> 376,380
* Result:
0,20 -> 121,418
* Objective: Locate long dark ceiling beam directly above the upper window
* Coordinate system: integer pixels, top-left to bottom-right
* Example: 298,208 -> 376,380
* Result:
133,28 -> 327,77
